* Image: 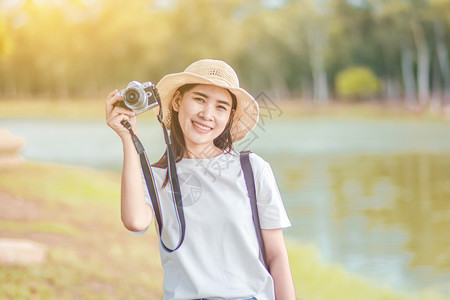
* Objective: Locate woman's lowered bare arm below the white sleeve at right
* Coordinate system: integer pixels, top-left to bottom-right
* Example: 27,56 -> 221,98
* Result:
261,228 -> 295,300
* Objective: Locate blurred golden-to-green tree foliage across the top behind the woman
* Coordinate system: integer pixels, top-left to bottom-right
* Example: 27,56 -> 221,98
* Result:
0,0 -> 450,98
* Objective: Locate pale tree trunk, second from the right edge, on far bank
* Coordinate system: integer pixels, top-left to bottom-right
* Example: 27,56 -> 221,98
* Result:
412,22 -> 430,107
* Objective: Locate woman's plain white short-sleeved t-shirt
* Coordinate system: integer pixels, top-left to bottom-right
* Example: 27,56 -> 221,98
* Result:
138,152 -> 291,300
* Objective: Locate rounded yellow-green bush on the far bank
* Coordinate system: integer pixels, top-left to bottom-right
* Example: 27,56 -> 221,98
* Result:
336,67 -> 379,99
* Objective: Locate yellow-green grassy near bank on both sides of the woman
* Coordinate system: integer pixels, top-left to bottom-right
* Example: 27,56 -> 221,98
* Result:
0,163 -> 440,300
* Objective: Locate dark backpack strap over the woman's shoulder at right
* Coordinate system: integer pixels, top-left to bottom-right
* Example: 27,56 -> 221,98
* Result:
240,151 -> 269,270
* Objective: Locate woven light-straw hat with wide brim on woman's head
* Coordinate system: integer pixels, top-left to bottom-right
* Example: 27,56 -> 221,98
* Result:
156,59 -> 259,142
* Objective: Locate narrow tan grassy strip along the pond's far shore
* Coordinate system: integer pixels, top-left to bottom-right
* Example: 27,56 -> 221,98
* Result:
0,95 -> 450,121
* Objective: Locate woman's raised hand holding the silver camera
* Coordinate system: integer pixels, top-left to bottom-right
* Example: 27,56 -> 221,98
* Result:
106,90 -> 136,139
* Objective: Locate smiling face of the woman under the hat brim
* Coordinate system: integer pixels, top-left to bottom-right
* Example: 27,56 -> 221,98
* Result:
173,84 -> 232,153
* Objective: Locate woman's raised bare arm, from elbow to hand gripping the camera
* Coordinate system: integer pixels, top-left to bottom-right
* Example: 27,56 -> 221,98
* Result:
106,90 -> 153,231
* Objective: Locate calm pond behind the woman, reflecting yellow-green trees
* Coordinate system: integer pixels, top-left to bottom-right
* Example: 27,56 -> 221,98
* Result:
0,118 -> 450,294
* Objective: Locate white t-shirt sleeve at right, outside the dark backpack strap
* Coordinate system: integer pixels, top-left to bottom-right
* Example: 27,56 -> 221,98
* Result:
250,154 -> 291,229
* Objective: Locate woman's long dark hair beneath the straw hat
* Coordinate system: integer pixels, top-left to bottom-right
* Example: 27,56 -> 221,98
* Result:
152,84 -> 237,187
